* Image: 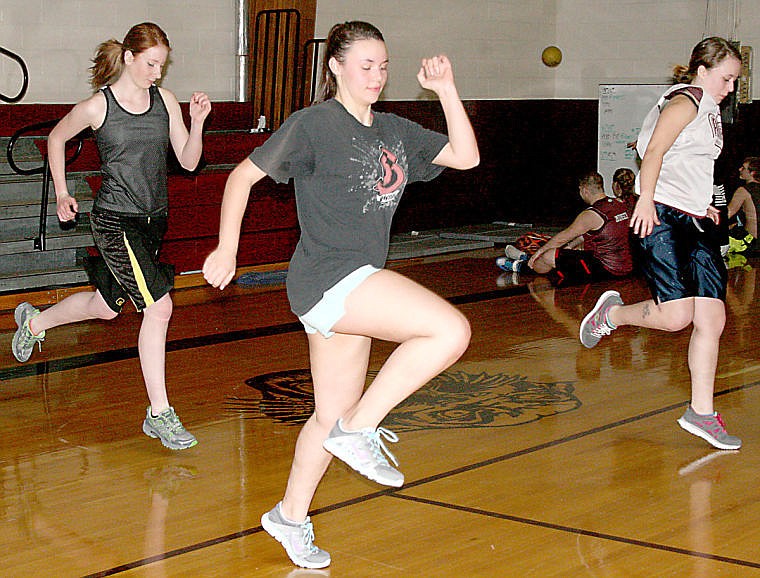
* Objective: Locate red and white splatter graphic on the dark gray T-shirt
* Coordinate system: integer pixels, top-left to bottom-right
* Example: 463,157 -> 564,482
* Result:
352,136 -> 408,213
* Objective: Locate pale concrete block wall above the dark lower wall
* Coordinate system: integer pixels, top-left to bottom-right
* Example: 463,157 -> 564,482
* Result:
0,0 -> 760,103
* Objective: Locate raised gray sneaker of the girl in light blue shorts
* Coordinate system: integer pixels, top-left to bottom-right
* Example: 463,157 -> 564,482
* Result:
322,419 -> 404,488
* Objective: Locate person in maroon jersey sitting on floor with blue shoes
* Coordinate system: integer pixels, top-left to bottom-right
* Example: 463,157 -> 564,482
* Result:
496,172 -> 633,284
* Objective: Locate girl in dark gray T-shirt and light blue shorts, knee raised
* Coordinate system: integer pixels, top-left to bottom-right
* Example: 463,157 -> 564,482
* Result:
203,22 -> 480,568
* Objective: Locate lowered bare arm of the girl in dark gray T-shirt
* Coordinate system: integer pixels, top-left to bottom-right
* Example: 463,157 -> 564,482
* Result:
203,159 -> 266,289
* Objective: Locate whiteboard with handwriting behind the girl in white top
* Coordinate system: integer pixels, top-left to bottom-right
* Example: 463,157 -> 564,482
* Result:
597,84 -> 671,195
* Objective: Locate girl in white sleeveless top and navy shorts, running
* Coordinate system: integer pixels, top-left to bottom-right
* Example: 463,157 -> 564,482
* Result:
580,37 -> 742,449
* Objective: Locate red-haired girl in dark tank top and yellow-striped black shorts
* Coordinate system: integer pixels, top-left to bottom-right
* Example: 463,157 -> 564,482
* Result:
12,22 -> 211,450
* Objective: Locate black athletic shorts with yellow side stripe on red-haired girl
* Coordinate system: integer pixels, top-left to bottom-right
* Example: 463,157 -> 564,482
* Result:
86,209 -> 174,313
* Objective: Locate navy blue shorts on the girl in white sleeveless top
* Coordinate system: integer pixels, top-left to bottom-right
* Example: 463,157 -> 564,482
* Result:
639,203 -> 728,303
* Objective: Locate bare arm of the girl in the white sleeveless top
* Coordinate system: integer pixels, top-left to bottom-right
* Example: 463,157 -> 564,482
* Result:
631,95 -> 697,238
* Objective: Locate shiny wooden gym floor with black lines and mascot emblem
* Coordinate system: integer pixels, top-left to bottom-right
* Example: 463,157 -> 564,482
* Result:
0,249 -> 760,578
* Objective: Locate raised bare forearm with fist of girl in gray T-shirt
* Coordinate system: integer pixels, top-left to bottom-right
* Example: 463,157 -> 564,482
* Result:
417,55 -> 480,169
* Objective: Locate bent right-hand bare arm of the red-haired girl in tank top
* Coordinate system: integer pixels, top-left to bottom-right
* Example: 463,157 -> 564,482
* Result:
159,88 -> 211,171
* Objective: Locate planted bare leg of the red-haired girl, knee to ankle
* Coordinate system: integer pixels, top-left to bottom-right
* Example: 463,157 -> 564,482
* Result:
137,293 -> 173,415
